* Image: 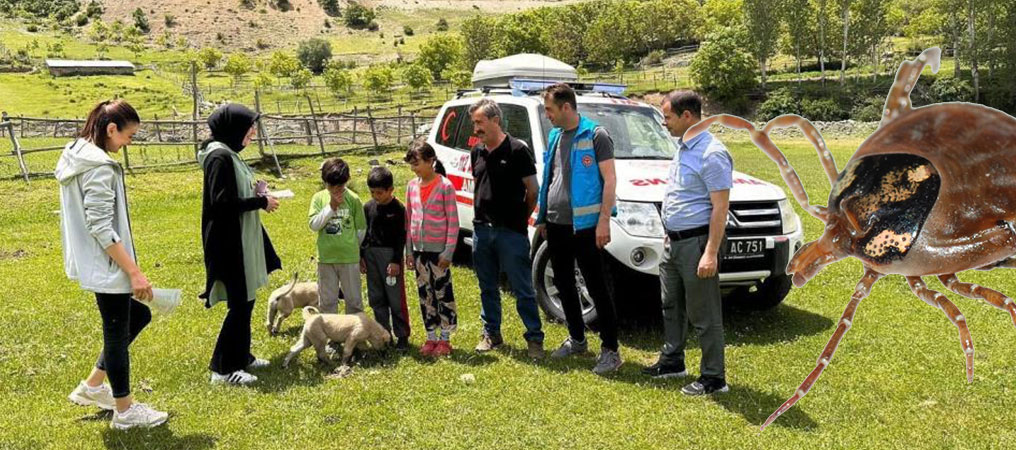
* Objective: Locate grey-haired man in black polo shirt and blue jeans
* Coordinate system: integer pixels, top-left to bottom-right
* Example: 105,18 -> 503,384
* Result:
469,99 -> 544,359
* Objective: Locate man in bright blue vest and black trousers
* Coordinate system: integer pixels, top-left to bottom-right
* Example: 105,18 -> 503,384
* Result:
536,83 -> 622,374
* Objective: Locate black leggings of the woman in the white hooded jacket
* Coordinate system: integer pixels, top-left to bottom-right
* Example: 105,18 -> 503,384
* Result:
96,293 -> 151,398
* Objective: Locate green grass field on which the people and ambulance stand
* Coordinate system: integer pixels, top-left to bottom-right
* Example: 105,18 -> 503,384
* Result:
0,137 -> 1016,449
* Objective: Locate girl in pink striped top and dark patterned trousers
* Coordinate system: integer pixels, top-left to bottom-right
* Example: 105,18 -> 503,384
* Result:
405,140 -> 458,357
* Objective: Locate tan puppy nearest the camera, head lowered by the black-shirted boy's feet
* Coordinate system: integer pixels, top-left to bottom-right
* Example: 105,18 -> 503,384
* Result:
282,306 -> 391,371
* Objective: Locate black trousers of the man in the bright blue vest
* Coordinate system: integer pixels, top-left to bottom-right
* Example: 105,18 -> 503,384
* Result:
547,223 -> 618,351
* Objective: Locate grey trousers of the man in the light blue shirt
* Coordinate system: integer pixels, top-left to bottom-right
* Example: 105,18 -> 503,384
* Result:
659,235 -> 726,381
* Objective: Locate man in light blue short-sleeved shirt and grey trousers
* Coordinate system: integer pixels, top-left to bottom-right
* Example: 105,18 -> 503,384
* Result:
643,90 -> 734,395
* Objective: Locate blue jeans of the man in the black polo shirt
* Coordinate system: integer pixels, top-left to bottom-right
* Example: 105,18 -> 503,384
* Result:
472,223 -> 544,342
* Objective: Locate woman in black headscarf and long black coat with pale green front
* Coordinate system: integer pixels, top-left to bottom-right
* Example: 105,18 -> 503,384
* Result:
198,105 -> 281,385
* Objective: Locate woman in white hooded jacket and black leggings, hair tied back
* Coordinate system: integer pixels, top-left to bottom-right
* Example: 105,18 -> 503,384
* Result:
56,100 -> 169,430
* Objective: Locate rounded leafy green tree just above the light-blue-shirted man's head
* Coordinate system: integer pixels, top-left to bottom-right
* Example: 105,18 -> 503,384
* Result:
689,28 -> 756,99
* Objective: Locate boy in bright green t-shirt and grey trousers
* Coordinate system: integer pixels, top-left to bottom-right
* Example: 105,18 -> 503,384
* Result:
310,157 -> 367,314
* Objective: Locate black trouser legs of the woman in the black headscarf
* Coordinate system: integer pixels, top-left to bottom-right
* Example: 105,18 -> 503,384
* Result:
208,300 -> 254,375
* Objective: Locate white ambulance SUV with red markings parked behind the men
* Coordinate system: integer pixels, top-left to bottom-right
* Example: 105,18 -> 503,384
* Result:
428,80 -> 804,323
